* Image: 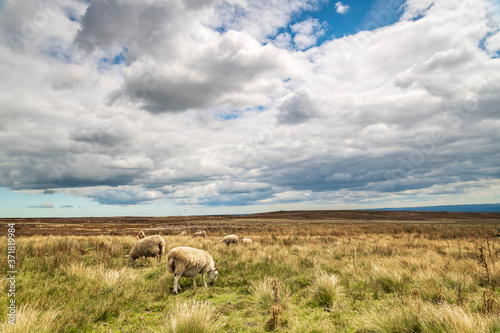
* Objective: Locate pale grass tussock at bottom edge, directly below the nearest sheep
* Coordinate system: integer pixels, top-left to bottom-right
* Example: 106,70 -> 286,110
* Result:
162,301 -> 224,333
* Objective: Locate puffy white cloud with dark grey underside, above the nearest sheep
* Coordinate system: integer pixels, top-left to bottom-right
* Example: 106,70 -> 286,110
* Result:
109,32 -> 285,113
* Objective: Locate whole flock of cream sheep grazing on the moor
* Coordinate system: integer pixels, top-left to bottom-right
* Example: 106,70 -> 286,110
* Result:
126,231 -> 252,294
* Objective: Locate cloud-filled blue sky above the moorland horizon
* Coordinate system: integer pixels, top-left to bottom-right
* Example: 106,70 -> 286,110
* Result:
0,0 -> 500,217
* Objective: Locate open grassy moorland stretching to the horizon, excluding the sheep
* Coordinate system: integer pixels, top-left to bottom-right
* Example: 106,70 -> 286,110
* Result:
0,211 -> 500,333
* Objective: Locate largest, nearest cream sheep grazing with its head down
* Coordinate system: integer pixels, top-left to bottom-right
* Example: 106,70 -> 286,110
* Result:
167,246 -> 219,295
